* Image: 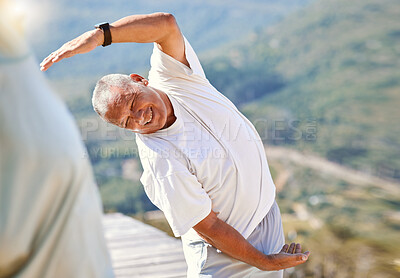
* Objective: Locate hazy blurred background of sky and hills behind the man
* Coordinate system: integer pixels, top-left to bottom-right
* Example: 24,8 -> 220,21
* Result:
17,0 -> 400,277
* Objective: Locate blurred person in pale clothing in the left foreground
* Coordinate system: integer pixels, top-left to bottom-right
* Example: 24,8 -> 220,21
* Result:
0,0 -> 114,278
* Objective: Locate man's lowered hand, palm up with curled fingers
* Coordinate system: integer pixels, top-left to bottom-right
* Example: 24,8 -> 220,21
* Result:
264,243 -> 310,270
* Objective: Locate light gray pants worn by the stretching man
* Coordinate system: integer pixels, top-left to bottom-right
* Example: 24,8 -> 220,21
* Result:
182,202 -> 285,278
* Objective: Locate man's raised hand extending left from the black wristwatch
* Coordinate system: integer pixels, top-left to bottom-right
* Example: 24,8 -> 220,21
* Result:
40,29 -> 104,71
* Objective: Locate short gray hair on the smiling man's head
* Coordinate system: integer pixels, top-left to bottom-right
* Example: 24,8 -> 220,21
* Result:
92,74 -> 133,119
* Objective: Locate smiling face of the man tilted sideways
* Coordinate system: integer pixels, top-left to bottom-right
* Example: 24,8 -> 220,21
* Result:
104,75 -> 172,134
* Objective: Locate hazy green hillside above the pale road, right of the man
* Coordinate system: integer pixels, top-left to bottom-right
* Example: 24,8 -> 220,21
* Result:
207,0 -> 400,180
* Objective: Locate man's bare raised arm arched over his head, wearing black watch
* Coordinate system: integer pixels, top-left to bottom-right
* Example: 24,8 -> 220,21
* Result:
40,13 -> 189,71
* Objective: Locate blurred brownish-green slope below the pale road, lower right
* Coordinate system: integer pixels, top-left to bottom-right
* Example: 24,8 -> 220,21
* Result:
266,147 -> 400,277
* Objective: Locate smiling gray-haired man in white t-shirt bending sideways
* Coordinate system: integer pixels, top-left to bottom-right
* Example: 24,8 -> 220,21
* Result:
41,13 -> 309,277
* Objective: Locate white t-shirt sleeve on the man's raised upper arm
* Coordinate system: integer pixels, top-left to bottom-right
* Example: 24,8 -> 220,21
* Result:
149,37 -> 206,84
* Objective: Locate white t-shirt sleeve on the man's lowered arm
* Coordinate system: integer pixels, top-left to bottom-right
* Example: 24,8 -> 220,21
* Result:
140,170 -> 211,237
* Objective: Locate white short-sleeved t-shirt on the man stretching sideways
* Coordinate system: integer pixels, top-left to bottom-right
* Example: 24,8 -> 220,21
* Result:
136,39 -> 275,238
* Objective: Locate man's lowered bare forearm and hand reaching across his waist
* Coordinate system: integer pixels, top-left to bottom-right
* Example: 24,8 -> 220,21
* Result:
193,211 -> 310,271
